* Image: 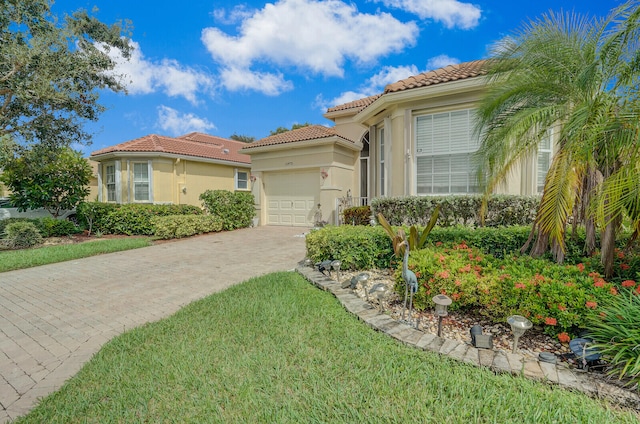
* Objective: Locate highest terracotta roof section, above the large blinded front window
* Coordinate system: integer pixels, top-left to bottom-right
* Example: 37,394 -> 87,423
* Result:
384,60 -> 487,94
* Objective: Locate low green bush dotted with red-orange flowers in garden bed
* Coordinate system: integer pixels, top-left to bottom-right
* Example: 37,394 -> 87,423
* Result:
396,242 -> 628,336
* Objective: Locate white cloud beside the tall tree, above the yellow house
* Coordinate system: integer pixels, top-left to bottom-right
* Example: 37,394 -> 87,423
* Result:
102,41 -> 214,103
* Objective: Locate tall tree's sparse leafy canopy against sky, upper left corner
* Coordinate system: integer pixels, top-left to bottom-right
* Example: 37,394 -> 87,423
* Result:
0,0 -> 131,146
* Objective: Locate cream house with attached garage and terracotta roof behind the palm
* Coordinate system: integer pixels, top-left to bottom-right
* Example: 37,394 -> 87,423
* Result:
242,60 -> 553,225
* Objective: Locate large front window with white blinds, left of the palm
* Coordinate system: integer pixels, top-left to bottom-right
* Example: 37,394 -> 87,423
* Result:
415,109 -> 480,195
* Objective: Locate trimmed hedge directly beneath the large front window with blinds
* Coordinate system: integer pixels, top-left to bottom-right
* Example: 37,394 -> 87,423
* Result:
371,195 -> 540,227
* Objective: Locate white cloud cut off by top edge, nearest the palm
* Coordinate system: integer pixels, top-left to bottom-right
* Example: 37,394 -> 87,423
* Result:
376,0 -> 482,29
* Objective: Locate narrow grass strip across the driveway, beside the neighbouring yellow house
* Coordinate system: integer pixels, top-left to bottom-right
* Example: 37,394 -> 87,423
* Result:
0,237 -> 151,272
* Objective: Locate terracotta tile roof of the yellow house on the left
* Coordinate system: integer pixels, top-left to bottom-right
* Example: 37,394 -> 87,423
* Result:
91,132 -> 251,164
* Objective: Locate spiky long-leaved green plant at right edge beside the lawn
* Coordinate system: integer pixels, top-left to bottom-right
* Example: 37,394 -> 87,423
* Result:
588,292 -> 640,383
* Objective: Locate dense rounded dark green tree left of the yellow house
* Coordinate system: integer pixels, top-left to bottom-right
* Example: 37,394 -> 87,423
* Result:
0,145 -> 91,217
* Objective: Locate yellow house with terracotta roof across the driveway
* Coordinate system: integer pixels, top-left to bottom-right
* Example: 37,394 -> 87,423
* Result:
90,132 -> 251,206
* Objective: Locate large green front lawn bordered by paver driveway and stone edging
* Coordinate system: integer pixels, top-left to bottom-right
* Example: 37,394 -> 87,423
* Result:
17,272 -> 638,424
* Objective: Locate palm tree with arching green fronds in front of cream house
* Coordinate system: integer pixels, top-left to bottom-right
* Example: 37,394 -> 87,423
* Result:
476,1 -> 640,275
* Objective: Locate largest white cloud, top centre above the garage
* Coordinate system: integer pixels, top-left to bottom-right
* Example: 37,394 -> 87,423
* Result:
201,0 -> 418,91
